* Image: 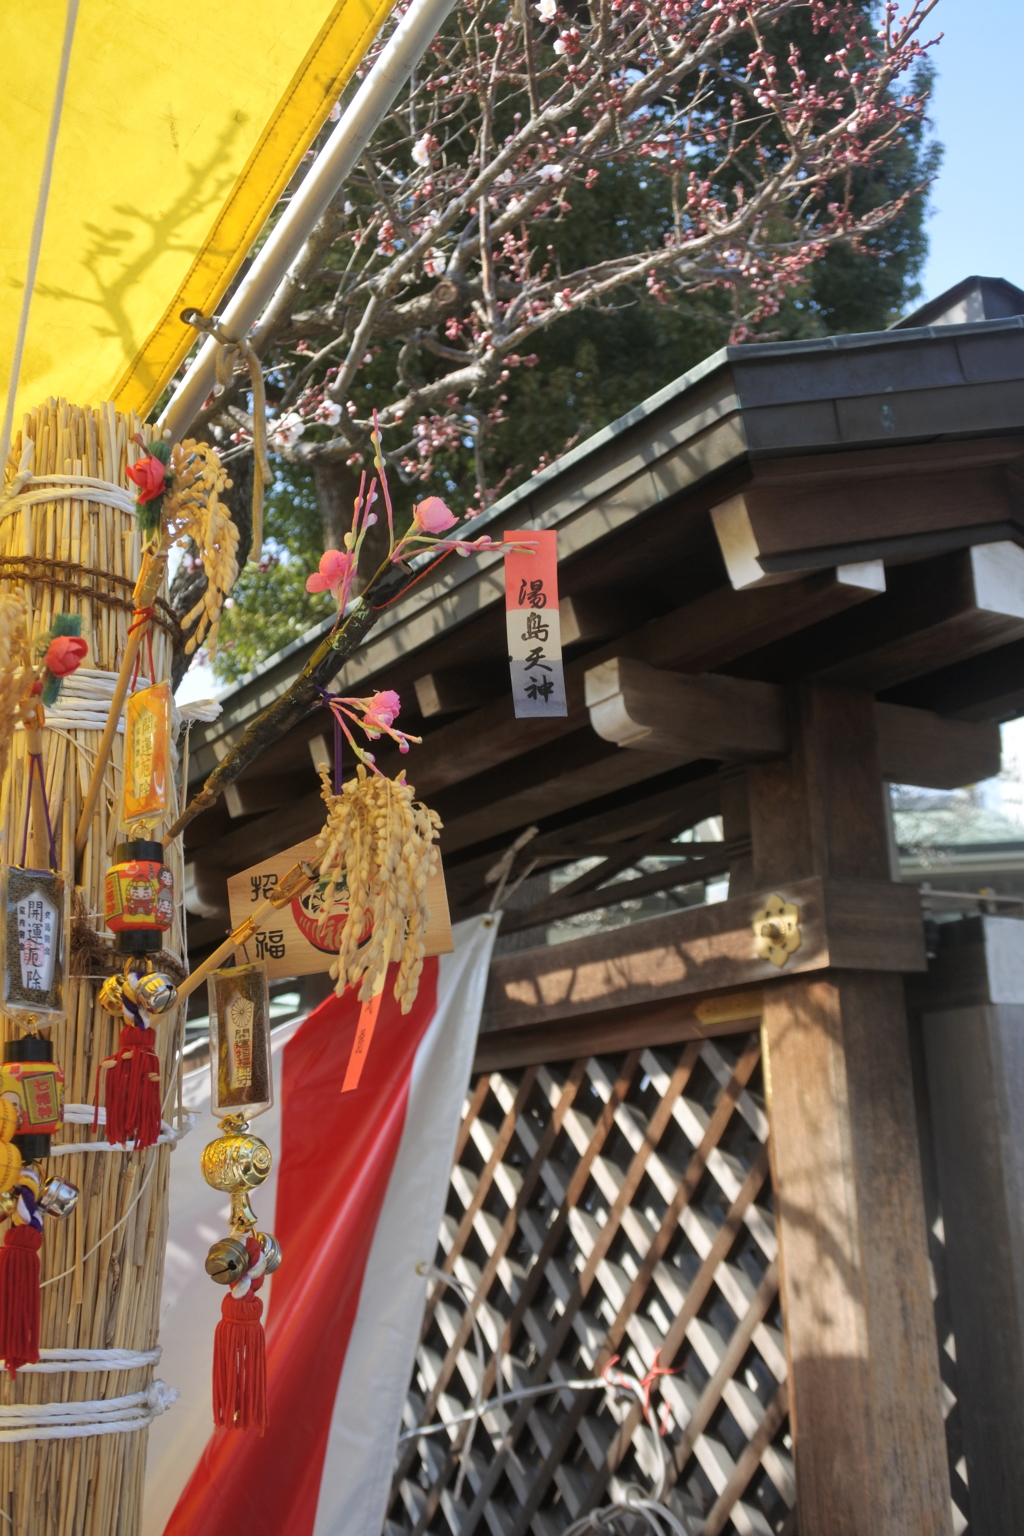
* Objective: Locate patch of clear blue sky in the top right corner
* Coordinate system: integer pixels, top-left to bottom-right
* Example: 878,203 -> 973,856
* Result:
921,0 -> 1024,298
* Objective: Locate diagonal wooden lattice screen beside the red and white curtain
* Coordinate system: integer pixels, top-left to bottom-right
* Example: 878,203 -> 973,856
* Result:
385,1034 -> 795,1536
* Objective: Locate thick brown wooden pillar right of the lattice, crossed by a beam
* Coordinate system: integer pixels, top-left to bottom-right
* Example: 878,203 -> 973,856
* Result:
748,687 -> 950,1536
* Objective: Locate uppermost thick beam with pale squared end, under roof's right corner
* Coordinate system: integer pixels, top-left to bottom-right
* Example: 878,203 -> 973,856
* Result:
711,464 -> 1024,587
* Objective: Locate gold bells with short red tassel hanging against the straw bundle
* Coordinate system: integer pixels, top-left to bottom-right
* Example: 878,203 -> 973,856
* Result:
92,957 -> 178,1147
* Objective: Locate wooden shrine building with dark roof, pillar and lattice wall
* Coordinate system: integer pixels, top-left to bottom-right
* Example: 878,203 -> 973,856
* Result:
186,280 -> 1024,1536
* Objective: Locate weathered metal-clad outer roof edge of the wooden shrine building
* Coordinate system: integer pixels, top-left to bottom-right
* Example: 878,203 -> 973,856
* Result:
192,316 -> 1024,779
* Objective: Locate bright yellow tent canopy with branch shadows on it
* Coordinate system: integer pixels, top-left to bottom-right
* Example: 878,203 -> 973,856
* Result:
0,0 -> 395,430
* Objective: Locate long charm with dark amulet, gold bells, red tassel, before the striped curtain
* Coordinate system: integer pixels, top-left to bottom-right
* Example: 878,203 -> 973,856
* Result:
203,965 -> 281,1435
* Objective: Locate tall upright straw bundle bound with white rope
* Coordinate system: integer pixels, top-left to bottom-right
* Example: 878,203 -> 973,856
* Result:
0,399 -> 184,1536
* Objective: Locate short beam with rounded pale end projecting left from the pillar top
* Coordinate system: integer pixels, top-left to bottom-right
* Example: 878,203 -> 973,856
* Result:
585,656 -> 789,762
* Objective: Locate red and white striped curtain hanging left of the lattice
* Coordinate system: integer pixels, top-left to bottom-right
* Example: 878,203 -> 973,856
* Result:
143,919 -> 496,1536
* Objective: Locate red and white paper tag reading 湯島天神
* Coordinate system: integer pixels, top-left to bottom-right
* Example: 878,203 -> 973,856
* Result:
505,528 -> 568,720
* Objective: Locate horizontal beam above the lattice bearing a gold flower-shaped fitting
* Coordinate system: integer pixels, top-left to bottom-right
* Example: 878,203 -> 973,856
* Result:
485,877 -> 927,1029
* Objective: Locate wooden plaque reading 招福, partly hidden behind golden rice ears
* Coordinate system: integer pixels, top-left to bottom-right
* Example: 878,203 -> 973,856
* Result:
227,837 -> 453,980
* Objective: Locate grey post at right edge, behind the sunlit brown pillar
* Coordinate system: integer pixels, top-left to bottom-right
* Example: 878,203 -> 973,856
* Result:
921,917 -> 1024,1536
